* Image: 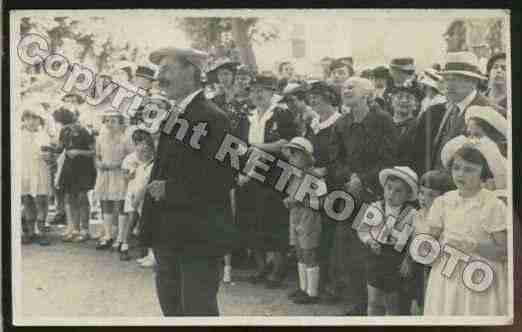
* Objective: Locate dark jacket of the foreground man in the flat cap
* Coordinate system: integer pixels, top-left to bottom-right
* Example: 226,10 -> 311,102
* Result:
142,93 -> 239,256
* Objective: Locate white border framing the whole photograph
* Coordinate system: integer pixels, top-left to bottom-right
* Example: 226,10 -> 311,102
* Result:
10,9 -> 514,326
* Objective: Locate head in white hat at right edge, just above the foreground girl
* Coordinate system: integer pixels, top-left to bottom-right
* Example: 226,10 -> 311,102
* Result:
465,106 -> 508,157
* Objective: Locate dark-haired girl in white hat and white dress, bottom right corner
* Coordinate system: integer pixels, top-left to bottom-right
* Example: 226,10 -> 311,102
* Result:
424,145 -> 509,316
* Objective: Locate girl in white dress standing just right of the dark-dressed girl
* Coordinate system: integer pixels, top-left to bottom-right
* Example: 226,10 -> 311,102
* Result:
94,107 -> 133,251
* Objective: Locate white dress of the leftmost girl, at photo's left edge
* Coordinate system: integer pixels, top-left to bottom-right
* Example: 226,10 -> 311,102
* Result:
20,130 -> 52,197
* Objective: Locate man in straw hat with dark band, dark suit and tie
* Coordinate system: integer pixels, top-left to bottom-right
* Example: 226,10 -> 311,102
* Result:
411,52 -> 500,175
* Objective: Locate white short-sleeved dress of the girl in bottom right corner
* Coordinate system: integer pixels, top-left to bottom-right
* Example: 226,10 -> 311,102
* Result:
424,189 -> 508,316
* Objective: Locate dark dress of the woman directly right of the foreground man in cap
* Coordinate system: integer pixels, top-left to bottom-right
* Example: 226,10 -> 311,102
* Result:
237,102 -> 298,251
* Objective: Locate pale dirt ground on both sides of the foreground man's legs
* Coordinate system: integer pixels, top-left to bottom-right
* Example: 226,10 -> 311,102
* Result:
18,229 -> 345,319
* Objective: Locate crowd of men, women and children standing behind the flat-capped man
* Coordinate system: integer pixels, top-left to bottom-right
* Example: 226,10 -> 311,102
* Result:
20,21 -> 510,315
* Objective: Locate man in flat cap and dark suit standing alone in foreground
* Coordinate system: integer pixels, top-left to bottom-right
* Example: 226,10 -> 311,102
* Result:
138,48 -> 239,316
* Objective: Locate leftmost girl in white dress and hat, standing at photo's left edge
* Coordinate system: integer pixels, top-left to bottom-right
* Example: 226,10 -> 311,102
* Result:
20,102 -> 52,245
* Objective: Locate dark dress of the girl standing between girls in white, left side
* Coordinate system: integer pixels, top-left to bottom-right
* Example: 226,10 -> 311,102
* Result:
58,123 -> 96,194
